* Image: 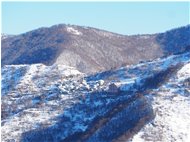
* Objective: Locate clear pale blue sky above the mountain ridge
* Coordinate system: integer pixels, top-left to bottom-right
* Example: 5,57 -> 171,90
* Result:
2,2 -> 190,35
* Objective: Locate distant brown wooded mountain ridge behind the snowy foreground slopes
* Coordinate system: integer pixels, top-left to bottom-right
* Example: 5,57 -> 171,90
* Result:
1,24 -> 190,73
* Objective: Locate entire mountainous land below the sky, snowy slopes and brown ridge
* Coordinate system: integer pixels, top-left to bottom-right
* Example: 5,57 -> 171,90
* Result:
1,25 -> 190,142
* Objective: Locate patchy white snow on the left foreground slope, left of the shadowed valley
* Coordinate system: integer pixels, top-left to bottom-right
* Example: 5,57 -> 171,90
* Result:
1,64 -> 83,142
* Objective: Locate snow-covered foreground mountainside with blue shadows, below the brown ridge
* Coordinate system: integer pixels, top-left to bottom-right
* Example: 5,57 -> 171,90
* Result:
1,51 -> 190,142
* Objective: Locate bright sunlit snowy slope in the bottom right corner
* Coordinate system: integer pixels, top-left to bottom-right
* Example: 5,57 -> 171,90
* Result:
132,62 -> 190,142
